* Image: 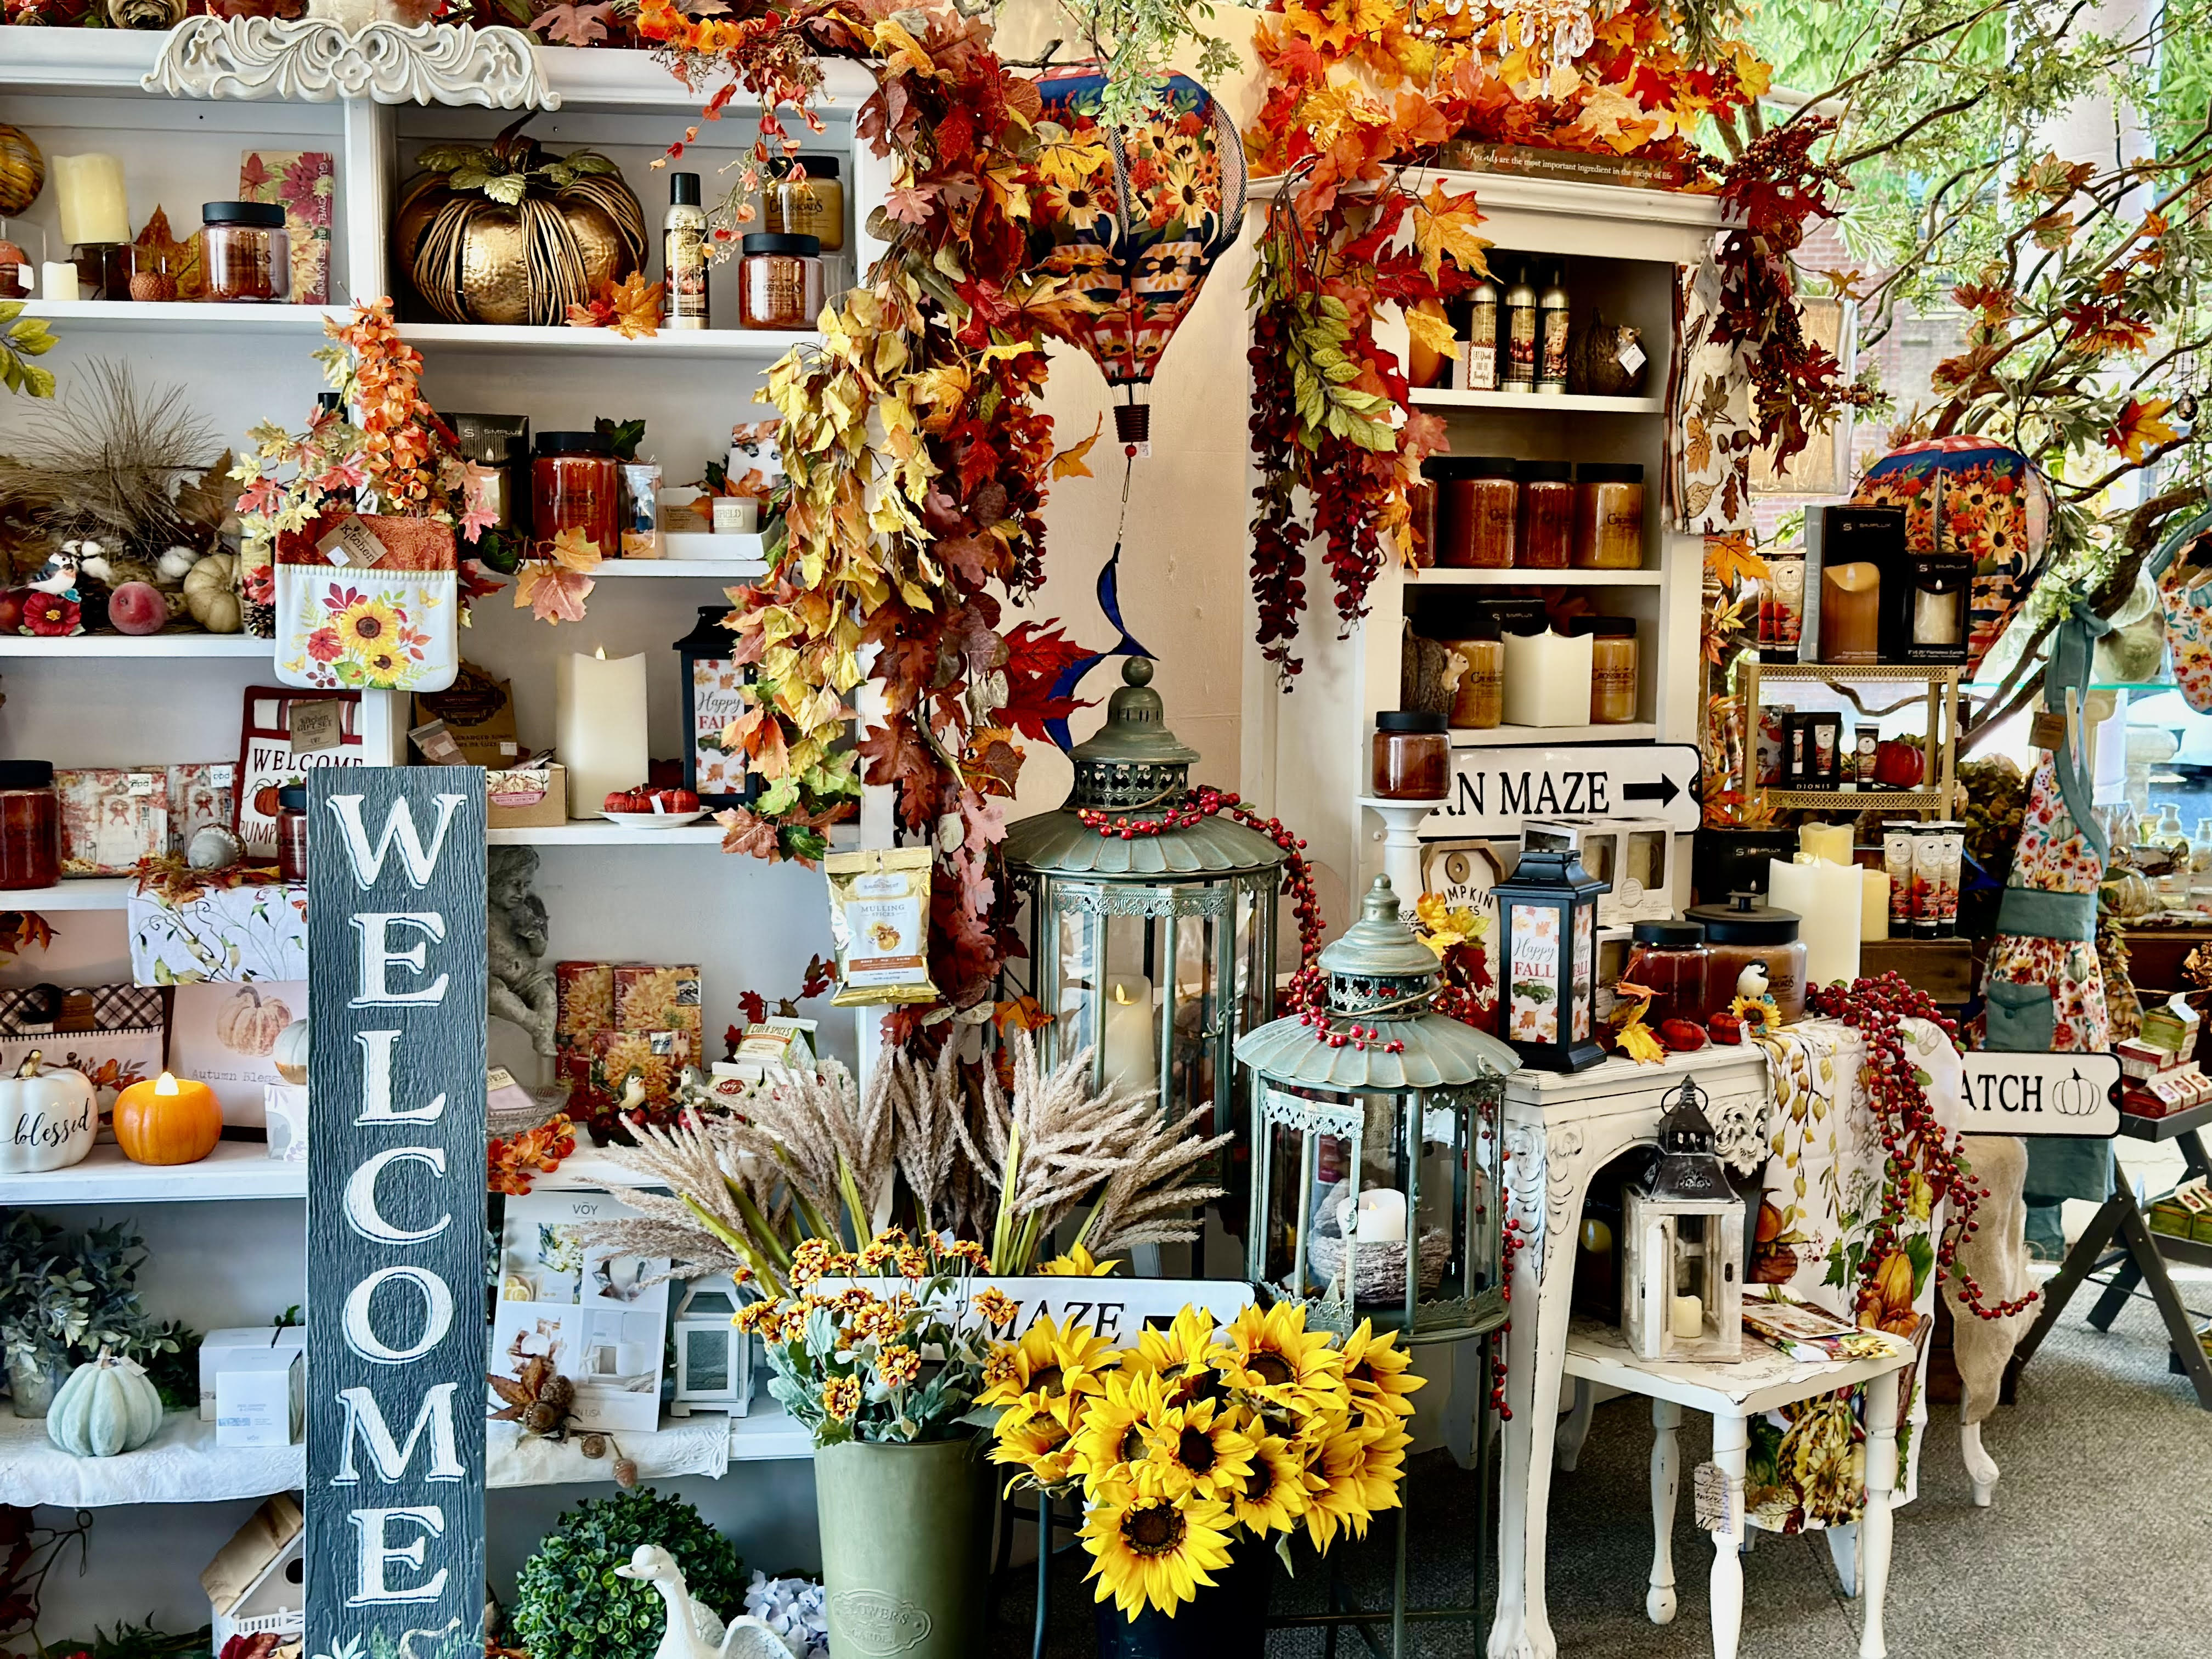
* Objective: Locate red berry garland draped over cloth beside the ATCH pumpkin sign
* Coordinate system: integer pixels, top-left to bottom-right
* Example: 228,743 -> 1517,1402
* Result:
1805,973 -> 2035,1318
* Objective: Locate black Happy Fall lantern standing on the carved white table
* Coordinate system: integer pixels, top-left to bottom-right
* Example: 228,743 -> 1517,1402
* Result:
1491,847 -> 1606,1070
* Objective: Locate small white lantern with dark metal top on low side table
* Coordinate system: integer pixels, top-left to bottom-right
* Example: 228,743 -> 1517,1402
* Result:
1621,1077 -> 1743,1365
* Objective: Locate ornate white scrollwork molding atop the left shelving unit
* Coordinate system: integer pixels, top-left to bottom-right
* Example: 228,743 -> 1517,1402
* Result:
142,18 -> 562,109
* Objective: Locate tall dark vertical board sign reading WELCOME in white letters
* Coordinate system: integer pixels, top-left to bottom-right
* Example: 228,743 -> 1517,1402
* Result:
307,765 -> 484,1659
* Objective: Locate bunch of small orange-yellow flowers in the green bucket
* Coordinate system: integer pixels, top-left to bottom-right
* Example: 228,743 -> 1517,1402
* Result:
737,1228 -> 1015,1447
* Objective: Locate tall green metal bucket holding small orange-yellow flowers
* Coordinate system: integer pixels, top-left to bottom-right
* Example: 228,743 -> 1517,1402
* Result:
814,1438 -> 991,1659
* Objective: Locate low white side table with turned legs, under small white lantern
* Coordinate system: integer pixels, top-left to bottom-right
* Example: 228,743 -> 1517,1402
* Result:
1566,1318 -> 1916,1659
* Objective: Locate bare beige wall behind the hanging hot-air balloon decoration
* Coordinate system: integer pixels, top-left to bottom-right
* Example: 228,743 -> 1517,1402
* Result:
997,0 -> 1256,816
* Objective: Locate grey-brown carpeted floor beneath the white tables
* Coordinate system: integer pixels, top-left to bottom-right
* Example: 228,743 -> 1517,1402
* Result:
991,1276 -> 2212,1659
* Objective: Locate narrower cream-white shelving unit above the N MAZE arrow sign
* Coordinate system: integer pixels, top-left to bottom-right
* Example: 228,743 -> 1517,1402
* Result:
1243,170 -> 1721,916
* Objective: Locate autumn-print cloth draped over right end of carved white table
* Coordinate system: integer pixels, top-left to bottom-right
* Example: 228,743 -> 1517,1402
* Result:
1743,1020 -> 1966,1533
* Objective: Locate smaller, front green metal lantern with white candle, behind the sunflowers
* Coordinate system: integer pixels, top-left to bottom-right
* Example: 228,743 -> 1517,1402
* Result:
1237,876 -> 1520,1342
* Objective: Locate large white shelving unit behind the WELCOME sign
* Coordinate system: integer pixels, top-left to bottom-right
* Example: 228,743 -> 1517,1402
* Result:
0,29 -> 889,1628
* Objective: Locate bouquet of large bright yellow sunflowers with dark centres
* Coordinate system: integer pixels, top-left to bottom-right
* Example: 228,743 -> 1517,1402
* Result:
978,1303 -> 1423,1619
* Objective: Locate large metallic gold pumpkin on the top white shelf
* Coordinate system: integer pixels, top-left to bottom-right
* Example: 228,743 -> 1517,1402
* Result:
392,117 -> 648,328
